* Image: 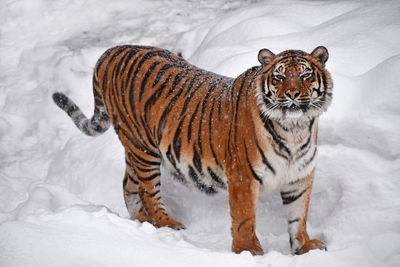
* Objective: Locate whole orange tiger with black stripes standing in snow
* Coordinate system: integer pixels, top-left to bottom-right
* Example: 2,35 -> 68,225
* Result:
52,45 -> 333,255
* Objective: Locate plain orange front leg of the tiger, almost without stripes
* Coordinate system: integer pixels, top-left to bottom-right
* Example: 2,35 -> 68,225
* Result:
228,175 -> 264,255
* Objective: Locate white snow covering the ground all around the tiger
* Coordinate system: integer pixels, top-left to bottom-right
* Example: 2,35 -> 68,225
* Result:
0,0 -> 400,267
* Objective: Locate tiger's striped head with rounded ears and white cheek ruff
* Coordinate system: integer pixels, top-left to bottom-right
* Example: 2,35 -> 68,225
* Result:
256,46 -> 333,122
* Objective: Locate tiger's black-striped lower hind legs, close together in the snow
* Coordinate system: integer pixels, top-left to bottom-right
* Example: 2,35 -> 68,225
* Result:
124,153 -> 184,229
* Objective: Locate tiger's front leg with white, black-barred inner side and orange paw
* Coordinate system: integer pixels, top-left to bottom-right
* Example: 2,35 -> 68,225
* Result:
281,171 -> 326,254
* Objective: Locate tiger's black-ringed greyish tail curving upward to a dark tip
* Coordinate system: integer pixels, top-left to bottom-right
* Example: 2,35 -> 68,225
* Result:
53,90 -> 111,136
